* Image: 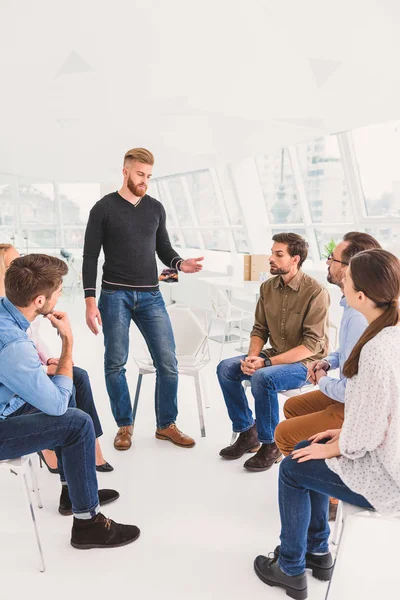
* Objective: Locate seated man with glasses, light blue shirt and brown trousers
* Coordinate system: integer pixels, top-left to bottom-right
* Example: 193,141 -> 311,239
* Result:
275,231 -> 381,468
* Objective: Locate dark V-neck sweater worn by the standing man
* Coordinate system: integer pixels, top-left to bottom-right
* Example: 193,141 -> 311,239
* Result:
83,192 -> 182,298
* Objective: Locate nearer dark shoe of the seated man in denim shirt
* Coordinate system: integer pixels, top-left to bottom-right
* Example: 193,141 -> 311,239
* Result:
71,513 -> 140,550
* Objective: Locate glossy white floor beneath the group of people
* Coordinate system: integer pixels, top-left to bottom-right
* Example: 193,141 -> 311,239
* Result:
0,298 -> 327,600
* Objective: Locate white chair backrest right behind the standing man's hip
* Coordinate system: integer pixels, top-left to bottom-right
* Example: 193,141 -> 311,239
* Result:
167,304 -> 208,357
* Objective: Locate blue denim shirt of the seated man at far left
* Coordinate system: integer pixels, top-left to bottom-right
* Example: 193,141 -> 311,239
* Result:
0,298 -> 72,419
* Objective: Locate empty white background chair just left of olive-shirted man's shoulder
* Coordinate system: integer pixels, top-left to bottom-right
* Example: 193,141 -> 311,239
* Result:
208,285 -> 254,362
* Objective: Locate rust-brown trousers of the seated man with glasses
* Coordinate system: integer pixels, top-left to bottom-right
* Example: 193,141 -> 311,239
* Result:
275,390 -> 344,456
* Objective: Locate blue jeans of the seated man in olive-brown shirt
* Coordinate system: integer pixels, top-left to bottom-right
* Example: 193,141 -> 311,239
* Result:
217,356 -> 307,444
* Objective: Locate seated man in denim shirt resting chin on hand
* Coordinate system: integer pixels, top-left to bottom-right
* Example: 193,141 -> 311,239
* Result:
0,254 -> 140,549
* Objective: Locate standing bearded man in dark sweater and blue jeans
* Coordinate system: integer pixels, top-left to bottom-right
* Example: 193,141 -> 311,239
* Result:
83,148 -> 203,450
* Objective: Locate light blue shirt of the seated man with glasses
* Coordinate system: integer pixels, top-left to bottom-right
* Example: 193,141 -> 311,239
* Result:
319,296 -> 368,402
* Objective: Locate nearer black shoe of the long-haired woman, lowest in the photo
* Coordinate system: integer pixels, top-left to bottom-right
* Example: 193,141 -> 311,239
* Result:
254,555 -> 307,600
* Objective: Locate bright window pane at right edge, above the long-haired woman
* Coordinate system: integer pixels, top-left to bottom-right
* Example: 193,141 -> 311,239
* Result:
352,121 -> 400,218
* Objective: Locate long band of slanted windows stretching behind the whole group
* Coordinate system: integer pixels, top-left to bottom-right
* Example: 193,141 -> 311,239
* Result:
0,122 -> 400,268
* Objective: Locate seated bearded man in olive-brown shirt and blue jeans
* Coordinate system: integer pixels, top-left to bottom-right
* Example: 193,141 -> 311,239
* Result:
217,233 -> 329,471
